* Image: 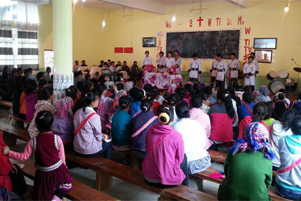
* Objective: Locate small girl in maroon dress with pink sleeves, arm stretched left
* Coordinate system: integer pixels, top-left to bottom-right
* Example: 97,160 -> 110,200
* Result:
2,111 -> 73,200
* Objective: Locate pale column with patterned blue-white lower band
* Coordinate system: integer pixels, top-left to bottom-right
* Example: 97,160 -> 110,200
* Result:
52,0 -> 73,100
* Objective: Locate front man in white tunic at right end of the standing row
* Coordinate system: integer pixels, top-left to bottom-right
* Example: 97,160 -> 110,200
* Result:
244,56 -> 256,92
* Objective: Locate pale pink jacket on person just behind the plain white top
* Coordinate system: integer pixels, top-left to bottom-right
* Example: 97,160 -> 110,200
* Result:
189,108 -> 213,149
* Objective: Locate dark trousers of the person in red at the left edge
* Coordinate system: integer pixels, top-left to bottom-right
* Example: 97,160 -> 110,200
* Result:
9,164 -> 27,195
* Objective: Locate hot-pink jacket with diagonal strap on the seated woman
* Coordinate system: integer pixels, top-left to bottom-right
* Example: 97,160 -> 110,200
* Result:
142,124 -> 185,185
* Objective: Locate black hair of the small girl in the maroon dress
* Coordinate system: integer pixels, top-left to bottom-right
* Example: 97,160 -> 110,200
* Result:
35,111 -> 53,132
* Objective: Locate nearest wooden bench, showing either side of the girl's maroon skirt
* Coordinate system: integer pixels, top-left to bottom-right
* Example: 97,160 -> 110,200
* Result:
22,160 -> 118,201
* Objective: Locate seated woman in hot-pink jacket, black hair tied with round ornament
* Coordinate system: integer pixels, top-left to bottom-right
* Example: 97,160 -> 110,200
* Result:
142,106 -> 188,187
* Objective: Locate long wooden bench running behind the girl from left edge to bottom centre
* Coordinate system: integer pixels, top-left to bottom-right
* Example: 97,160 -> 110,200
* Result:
0,122 -> 216,200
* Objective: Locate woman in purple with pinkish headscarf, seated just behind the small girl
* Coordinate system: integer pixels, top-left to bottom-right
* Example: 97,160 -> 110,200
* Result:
52,97 -> 74,145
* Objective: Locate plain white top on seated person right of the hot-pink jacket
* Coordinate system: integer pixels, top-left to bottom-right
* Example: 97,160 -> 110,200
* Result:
172,118 -> 207,161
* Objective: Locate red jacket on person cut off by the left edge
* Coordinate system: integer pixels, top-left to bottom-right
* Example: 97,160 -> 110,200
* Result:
0,133 -> 13,191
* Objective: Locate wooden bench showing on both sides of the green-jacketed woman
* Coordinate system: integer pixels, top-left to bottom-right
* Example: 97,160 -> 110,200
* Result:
190,167 -> 287,201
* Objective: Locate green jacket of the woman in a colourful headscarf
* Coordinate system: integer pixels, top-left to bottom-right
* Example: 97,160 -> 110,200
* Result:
218,152 -> 273,201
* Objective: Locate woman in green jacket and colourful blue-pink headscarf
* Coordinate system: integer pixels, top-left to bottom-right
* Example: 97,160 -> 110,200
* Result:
218,122 -> 274,200
